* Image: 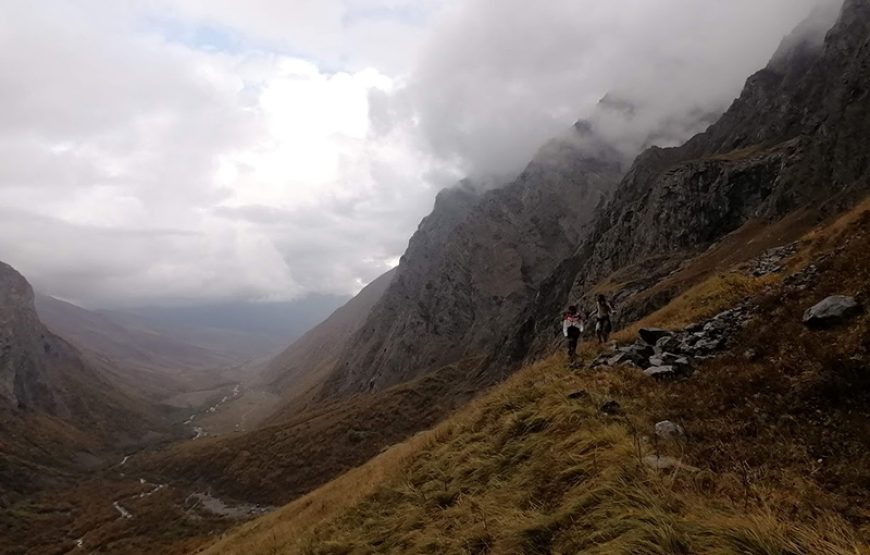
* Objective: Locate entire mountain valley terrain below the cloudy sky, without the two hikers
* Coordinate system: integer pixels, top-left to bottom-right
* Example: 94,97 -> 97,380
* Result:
0,0 -> 870,555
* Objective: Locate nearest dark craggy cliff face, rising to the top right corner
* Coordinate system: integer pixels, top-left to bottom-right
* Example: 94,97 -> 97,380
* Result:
510,0 -> 870,358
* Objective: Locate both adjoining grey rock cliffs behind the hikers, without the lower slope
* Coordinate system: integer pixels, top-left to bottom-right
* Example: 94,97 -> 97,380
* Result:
325,0 -> 870,396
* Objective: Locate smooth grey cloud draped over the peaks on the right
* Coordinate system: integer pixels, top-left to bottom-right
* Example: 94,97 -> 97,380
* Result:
386,0 -> 839,173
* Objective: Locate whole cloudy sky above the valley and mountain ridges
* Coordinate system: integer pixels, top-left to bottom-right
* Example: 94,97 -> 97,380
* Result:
0,0 -> 838,308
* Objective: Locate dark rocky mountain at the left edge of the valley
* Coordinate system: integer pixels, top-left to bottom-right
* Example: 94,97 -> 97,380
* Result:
0,262 -> 169,491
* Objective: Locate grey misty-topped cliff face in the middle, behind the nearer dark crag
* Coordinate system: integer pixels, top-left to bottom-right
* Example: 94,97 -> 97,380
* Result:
326,134 -> 622,395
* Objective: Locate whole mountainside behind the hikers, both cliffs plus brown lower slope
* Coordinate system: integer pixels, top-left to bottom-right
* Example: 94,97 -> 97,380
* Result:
133,1 -> 870,520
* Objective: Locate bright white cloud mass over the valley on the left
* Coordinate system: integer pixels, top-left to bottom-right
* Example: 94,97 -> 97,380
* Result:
0,2 -> 446,306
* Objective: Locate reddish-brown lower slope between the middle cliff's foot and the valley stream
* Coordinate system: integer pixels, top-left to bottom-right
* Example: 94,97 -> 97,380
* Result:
131,365 -> 484,505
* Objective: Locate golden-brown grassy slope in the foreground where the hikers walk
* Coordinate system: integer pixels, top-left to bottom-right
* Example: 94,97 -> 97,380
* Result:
198,203 -> 870,555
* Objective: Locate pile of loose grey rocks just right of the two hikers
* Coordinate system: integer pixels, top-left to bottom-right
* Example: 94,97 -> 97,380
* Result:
591,306 -> 750,379
